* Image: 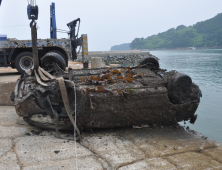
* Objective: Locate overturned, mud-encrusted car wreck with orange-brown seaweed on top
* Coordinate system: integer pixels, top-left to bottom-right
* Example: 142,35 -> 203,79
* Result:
12,54 -> 202,131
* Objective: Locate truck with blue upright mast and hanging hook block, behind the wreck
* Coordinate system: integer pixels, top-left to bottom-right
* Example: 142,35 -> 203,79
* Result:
0,0 -> 86,73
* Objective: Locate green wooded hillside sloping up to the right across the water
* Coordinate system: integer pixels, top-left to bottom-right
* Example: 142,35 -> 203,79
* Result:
130,13 -> 222,49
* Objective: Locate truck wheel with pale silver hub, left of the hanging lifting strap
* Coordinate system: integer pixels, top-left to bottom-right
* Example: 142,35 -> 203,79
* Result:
15,52 -> 34,74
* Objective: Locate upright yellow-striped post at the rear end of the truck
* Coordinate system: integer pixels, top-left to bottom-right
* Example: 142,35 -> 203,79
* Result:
81,34 -> 89,68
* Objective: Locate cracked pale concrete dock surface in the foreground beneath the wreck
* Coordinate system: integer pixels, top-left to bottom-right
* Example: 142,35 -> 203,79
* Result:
0,106 -> 222,170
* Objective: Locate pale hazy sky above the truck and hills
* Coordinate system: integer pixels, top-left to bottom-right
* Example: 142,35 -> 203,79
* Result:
0,0 -> 222,51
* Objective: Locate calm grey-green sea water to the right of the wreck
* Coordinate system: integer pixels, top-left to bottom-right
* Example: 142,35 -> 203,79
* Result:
150,49 -> 222,143
